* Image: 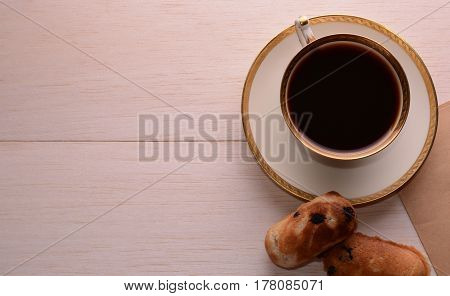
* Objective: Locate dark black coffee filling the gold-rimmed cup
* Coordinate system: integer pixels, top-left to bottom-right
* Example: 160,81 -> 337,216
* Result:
287,41 -> 401,150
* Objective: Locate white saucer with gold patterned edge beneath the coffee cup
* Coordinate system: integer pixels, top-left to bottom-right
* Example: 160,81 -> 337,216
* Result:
242,15 -> 437,205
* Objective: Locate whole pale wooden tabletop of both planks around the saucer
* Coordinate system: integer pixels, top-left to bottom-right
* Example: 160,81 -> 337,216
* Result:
0,0 -> 450,275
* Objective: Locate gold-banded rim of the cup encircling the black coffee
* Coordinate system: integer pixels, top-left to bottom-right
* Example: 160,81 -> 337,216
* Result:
280,34 -> 410,160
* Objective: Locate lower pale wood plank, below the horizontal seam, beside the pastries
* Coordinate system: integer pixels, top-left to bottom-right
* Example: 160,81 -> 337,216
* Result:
0,143 -> 432,275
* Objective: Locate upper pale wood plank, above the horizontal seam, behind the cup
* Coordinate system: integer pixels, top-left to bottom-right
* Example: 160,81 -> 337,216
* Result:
0,0 -> 450,141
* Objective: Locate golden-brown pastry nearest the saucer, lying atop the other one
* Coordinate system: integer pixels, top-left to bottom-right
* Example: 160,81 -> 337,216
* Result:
265,192 -> 356,269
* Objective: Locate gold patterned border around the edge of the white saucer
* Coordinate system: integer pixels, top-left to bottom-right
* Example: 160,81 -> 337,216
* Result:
241,15 -> 438,206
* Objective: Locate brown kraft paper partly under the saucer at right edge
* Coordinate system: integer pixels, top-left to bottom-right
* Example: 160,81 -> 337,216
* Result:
400,102 -> 450,275
